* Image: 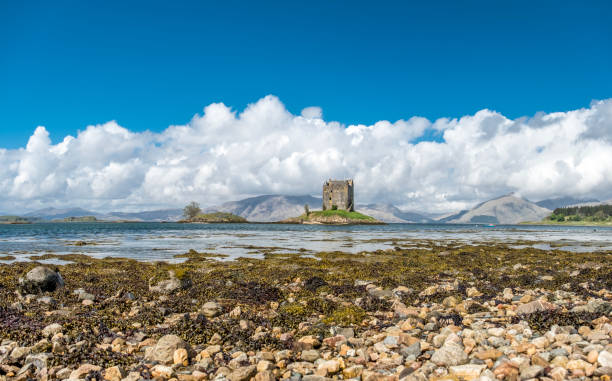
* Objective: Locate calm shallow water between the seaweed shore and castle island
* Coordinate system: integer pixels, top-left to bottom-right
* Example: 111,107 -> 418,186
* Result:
0,223 -> 612,263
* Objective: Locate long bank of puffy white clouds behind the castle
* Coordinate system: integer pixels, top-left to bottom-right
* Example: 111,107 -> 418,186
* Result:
0,96 -> 612,212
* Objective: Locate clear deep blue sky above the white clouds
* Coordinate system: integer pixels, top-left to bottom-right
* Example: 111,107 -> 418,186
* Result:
0,0 -> 612,148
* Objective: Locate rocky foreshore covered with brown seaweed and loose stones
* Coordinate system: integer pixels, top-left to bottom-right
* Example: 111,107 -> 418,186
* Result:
0,242 -> 612,381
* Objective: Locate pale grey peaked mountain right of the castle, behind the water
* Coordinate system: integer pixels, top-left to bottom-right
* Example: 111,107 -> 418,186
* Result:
443,195 -> 552,224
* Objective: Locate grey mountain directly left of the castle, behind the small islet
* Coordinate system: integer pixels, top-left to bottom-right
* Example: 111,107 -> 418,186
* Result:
205,195 -> 322,222
